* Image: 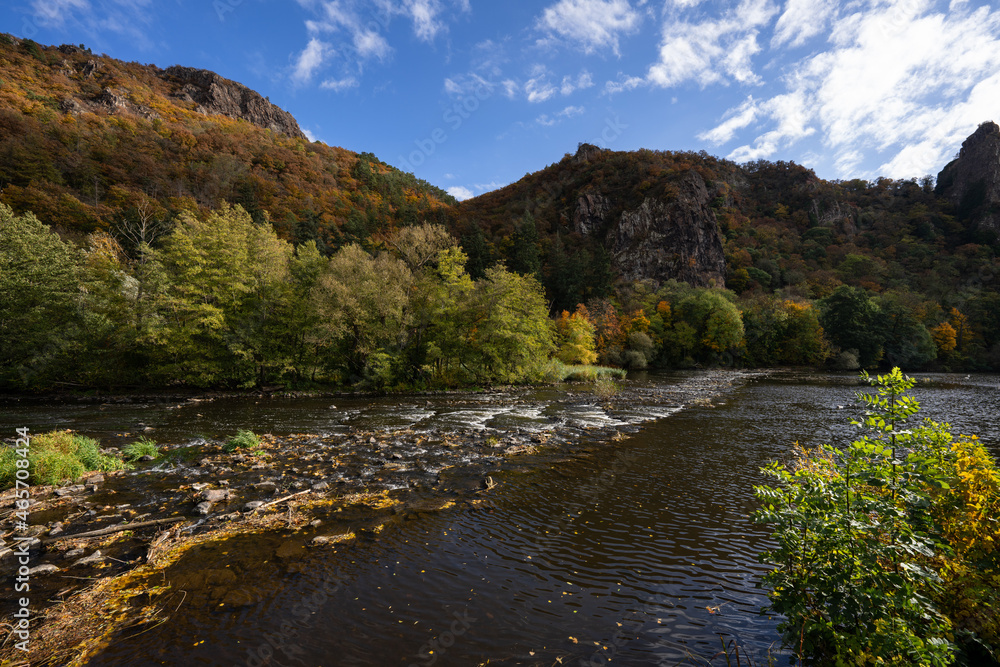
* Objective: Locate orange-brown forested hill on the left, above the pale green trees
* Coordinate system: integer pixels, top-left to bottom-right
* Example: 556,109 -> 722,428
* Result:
0,35 -> 454,248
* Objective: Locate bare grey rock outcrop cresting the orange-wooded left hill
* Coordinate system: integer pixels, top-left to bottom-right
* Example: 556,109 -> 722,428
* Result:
161,65 -> 306,139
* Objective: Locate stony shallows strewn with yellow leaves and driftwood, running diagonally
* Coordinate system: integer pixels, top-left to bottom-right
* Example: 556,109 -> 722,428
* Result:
0,371 -> 756,664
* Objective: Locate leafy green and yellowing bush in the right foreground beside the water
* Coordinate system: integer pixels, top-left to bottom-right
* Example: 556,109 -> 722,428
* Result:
755,368 -> 1000,666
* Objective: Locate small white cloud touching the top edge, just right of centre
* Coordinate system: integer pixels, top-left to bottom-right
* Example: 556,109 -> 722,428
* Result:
538,0 -> 642,55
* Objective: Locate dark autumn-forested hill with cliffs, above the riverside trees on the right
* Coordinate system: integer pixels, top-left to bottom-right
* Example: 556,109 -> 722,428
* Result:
455,135 -> 1000,309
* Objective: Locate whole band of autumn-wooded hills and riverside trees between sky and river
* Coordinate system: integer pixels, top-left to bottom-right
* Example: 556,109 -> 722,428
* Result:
0,36 -> 1000,388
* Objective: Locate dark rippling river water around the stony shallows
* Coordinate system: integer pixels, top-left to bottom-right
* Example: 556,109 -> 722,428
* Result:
7,372 -> 1000,667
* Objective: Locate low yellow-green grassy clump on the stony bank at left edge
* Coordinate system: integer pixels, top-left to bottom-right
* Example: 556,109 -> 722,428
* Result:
0,431 -> 126,488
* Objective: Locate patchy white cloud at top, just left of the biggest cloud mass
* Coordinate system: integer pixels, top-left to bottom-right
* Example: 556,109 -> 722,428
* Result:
647,0 -> 776,88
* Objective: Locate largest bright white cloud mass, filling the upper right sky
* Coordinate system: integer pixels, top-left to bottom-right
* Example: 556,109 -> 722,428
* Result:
700,0 -> 1000,178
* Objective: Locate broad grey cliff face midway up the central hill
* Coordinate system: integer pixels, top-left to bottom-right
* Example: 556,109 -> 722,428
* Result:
608,171 -> 726,287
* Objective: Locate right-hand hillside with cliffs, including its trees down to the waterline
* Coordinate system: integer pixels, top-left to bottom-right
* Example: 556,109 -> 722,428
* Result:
452,131 -> 1000,369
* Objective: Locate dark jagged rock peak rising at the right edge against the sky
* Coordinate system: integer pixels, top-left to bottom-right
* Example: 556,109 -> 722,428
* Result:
937,121 -> 1000,232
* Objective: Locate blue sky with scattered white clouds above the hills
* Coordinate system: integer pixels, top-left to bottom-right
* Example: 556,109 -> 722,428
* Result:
0,0 -> 1000,198
